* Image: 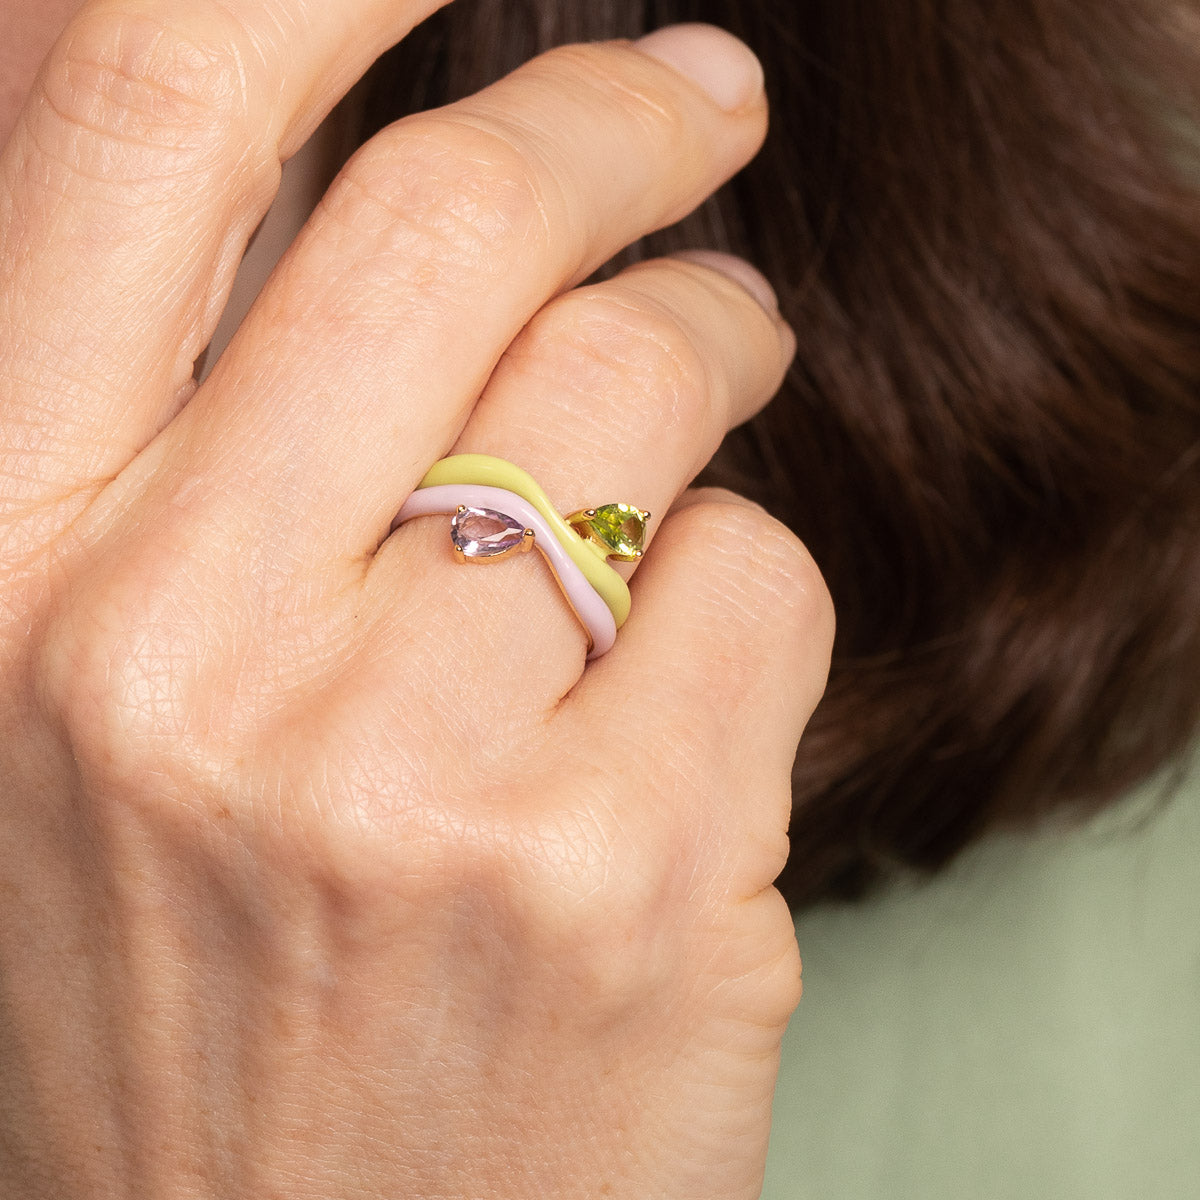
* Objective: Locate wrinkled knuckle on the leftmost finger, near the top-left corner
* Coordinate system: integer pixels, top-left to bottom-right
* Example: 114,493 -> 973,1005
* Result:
41,10 -> 247,175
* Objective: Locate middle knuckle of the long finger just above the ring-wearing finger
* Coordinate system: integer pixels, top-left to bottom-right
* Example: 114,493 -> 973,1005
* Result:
329,114 -> 547,288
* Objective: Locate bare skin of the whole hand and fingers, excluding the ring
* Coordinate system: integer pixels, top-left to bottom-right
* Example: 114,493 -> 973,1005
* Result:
0,0 -> 833,1200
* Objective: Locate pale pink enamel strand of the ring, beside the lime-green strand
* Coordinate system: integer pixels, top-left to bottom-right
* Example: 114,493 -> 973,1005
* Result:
392,484 -> 617,661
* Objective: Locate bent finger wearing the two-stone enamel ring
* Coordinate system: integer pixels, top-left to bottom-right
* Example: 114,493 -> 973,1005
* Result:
372,254 -> 794,698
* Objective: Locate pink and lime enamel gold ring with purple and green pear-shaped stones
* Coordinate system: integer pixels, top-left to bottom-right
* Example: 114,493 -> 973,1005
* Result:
392,455 -> 650,659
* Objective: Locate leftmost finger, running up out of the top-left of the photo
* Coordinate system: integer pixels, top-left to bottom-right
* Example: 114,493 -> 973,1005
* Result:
0,0 -> 444,523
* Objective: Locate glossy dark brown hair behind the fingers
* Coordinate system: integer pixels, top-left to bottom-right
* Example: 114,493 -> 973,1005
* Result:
364,0 -> 1200,905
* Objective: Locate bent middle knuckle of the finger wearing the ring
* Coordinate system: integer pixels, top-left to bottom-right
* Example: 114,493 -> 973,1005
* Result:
510,284 -> 720,453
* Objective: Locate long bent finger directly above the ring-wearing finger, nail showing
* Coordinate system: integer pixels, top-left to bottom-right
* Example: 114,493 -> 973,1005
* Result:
133,26 -> 764,564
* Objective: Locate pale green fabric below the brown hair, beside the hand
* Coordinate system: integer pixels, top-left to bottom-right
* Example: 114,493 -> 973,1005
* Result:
763,770 -> 1200,1200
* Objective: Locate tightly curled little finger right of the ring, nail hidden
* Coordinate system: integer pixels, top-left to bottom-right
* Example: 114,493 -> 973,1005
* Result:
568,488 -> 834,896
